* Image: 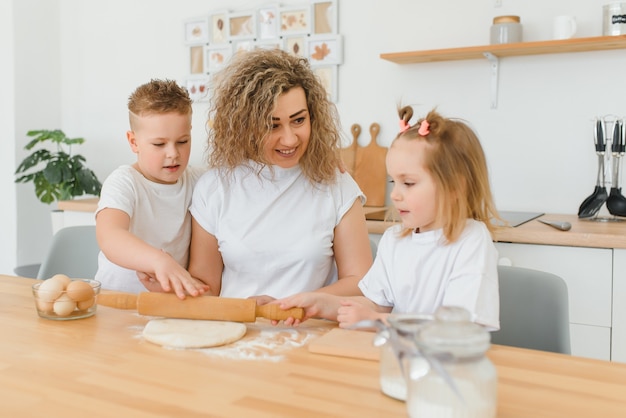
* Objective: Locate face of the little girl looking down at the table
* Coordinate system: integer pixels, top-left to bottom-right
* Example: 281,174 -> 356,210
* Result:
387,138 -> 443,232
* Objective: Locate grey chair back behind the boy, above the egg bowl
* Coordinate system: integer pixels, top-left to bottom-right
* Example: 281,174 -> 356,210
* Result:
37,225 -> 100,279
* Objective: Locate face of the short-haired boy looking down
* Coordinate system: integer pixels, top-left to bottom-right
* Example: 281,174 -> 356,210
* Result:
126,112 -> 191,184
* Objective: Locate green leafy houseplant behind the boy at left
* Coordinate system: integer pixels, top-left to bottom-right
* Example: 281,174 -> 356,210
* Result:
15,129 -> 102,204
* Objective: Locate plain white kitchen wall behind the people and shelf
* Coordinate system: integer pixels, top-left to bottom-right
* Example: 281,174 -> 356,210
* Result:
0,0 -> 626,273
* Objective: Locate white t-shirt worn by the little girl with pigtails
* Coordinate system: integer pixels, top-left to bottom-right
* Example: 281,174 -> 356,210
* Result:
359,219 -> 500,330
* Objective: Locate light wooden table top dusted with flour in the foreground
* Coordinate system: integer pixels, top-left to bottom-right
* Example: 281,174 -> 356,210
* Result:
0,275 -> 626,418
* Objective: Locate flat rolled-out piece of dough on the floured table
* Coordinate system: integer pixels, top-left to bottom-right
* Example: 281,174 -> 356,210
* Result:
143,318 -> 247,348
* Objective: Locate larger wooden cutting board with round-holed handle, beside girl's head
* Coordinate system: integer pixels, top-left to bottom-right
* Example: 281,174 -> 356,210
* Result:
354,122 -> 387,206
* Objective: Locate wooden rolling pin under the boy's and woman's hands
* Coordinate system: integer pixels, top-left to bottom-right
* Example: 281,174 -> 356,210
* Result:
97,291 -> 304,322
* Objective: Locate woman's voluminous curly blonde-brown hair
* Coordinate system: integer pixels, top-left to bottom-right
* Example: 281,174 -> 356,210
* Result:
207,49 -> 341,183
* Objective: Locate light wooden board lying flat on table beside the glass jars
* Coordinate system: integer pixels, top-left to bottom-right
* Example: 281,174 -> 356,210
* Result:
309,328 -> 380,361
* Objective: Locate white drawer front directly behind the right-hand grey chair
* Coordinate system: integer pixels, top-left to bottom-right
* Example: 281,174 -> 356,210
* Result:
495,242 -> 613,328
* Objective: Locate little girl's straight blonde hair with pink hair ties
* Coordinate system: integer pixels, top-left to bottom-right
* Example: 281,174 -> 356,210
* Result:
394,106 -> 500,243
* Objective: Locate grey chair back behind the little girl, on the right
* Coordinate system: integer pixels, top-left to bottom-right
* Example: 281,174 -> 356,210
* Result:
491,266 -> 571,354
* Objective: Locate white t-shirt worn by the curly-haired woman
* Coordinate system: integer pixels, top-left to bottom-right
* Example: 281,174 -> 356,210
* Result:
190,162 -> 365,298
